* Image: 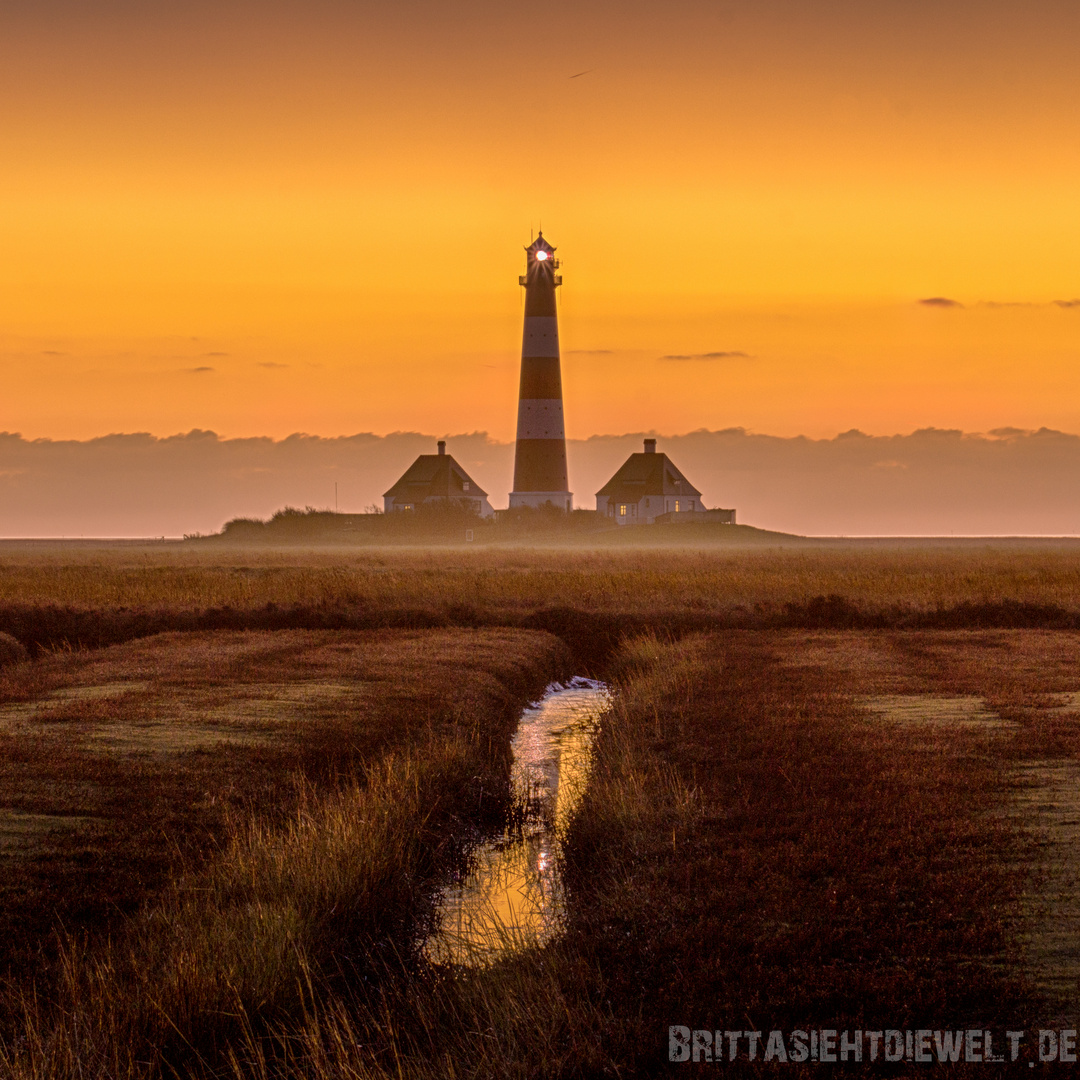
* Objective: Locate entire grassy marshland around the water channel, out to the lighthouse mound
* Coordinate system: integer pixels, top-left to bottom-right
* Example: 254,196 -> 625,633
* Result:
0,544 -> 1080,1080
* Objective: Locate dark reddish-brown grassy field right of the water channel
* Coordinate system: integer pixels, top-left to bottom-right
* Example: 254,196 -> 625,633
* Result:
223,632 -> 1080,1080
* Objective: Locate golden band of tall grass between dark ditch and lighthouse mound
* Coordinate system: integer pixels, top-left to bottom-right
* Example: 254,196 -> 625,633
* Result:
6,541 -> 1080,615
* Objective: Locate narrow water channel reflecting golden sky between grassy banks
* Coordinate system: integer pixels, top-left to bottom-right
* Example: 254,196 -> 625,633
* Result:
424,678 -> 610,967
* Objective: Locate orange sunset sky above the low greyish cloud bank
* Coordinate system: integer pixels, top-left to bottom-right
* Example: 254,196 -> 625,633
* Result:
0,0 -> 1080,440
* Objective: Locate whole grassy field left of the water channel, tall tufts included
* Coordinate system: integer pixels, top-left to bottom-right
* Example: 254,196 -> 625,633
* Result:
0,630 -> 567,1076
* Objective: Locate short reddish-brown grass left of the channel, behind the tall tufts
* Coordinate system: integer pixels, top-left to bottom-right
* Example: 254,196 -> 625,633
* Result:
0,630 -> 565,993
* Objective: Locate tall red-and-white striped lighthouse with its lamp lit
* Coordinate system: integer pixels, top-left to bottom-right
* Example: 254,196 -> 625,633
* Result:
510,232 -> 572,510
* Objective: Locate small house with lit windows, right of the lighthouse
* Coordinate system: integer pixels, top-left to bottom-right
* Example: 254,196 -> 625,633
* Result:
596,438 -> 735,525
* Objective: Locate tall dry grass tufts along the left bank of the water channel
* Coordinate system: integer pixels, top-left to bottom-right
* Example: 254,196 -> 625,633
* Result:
0,740 -> 483,1080
